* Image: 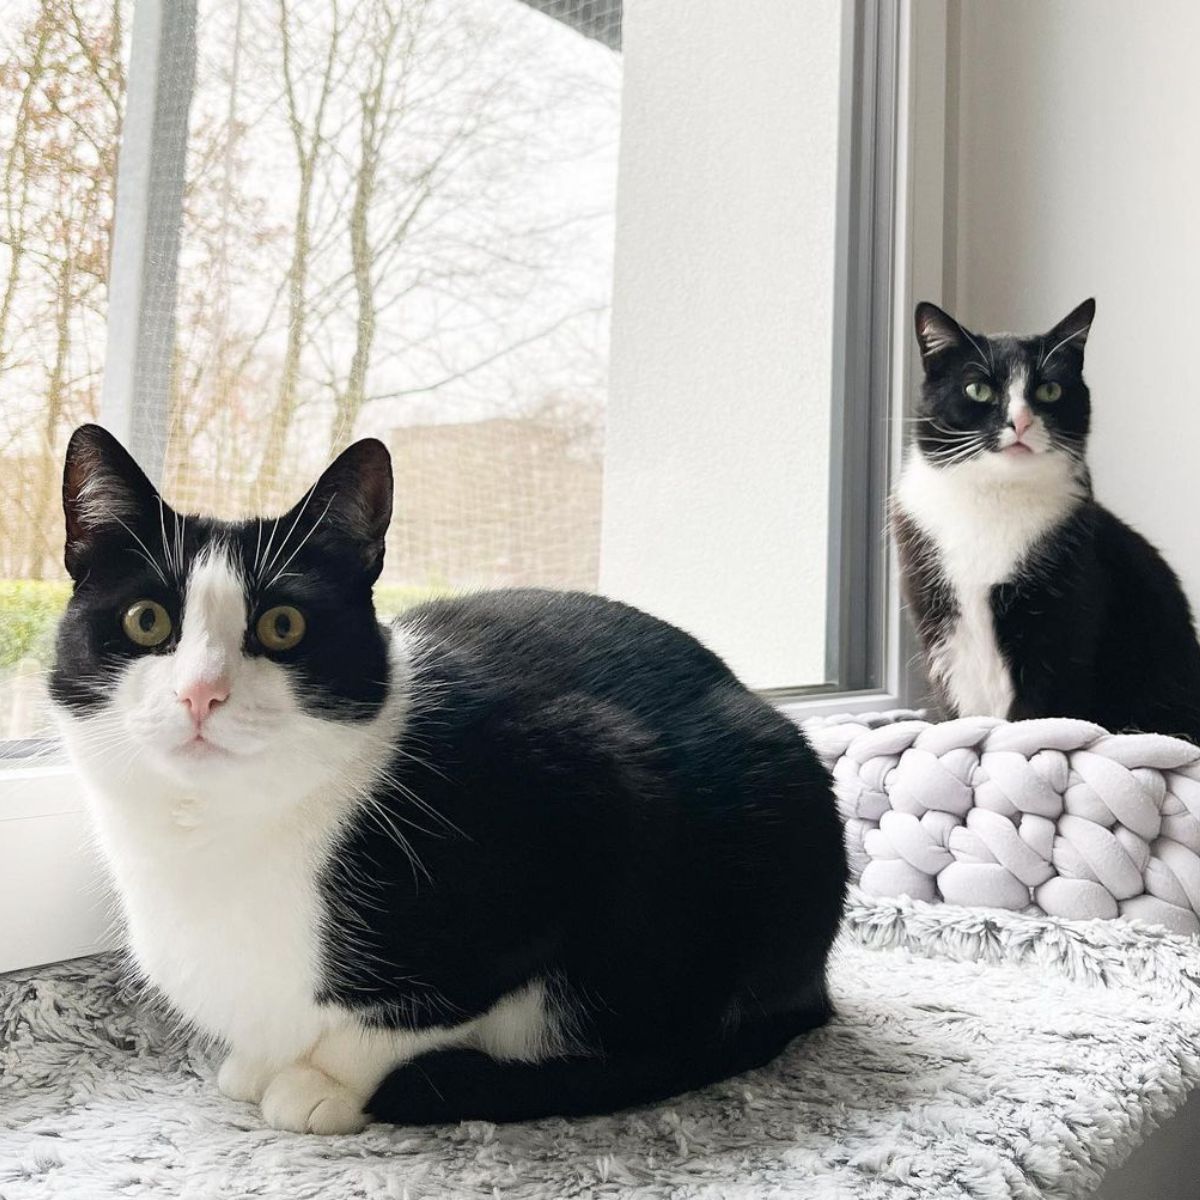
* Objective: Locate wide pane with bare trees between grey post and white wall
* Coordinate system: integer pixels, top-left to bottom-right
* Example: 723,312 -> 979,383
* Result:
164,0 -> 622,610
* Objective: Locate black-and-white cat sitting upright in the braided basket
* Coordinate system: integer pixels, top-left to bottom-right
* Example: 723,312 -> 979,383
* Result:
892,300 -> 1200,742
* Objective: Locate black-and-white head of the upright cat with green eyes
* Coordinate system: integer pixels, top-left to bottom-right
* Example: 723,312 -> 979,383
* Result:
916,300 -> 1096,479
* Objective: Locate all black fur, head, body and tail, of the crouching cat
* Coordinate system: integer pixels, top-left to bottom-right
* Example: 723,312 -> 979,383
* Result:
52,426 -> 846,1123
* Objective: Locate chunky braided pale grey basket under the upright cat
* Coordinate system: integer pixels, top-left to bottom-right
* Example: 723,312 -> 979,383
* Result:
805,713 -> 1200,935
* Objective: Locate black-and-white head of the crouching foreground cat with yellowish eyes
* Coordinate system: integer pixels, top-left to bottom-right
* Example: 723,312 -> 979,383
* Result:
50,425 -> 391,802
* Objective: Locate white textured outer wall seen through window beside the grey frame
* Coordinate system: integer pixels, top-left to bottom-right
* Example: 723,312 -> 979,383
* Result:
600,0 -> 841,688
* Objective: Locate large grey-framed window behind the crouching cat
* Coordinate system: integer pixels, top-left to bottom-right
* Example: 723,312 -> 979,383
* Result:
0,0 -> 904,758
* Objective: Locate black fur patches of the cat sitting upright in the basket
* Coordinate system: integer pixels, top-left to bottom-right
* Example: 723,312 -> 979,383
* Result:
893,300 -> 1200,743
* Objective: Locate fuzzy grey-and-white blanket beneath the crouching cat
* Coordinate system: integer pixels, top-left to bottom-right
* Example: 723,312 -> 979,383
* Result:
0,895 -> 1200,1200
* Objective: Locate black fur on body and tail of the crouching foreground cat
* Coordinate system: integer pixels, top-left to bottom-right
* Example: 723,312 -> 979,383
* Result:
350,590 -> 845,1121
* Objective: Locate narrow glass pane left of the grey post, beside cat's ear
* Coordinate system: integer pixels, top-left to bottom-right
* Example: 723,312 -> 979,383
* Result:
0,0 -> 132,742
